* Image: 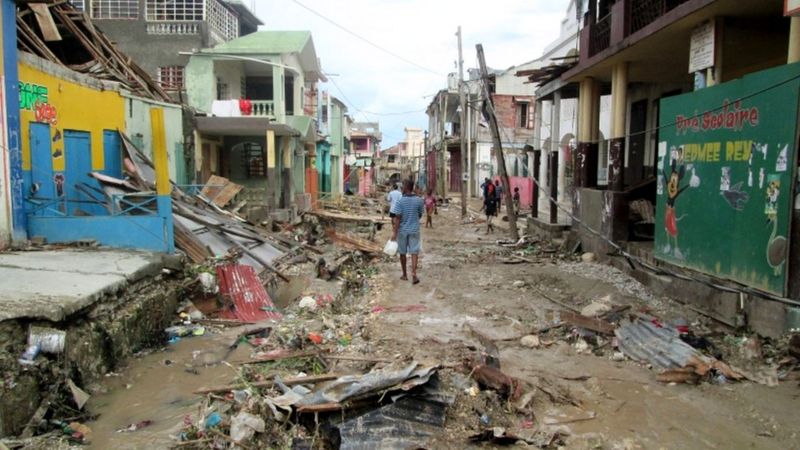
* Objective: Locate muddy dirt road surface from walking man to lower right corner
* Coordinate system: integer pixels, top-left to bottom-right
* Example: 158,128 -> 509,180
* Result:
370,201 -> 800,449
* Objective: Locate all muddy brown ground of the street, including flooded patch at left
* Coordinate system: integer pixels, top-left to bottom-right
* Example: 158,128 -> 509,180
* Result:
17,201 -> 800,449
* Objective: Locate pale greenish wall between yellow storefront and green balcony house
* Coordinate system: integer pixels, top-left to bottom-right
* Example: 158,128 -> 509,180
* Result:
125,95 -> 186,184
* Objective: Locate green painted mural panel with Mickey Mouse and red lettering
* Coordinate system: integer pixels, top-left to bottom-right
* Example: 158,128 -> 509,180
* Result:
654,63 -> 800,295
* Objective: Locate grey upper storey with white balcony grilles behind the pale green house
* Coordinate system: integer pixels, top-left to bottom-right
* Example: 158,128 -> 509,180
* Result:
70,0 -> 264,99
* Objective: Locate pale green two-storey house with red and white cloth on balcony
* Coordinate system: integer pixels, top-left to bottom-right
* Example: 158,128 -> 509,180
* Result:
186,31 -> 324,216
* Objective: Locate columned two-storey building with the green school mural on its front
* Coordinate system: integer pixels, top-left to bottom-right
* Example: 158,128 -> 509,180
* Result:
548,0 -> 800,336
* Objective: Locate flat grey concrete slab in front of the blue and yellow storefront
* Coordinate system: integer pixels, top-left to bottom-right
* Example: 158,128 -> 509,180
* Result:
0,250 -> 165,322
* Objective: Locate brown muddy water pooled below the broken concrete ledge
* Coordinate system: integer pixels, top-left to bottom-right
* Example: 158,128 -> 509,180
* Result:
88,328 -> 249,450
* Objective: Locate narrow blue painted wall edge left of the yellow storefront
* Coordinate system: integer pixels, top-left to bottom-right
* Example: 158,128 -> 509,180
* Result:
2,0 -> 28,242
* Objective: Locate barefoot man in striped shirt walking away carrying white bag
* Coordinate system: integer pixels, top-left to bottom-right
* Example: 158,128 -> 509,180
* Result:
390,180 -> 424,284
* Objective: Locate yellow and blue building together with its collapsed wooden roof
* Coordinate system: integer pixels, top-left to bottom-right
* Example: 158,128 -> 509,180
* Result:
17,3 -> 177,253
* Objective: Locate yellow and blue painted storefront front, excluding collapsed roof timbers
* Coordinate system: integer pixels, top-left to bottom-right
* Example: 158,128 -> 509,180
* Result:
19,53 -> 174,252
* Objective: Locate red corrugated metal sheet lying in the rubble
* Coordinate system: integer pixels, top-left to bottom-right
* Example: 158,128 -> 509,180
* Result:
217,264 -> 283,322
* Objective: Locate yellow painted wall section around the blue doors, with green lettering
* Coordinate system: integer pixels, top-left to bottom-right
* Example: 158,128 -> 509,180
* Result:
19,63 -> 125,172
